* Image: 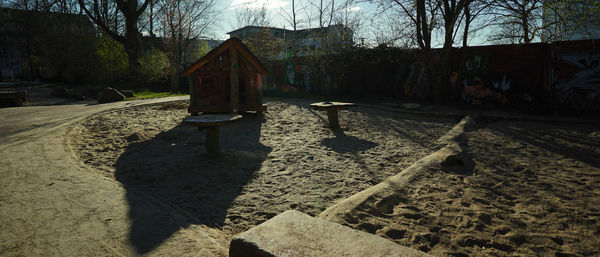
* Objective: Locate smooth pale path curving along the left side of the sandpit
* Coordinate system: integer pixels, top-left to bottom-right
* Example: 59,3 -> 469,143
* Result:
0,97 -> 226,256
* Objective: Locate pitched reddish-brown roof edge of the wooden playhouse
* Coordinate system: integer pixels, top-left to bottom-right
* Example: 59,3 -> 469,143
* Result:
183,37 -> 269,76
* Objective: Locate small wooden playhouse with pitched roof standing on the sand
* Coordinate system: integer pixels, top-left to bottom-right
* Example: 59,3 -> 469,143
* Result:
183,38 -> 269,115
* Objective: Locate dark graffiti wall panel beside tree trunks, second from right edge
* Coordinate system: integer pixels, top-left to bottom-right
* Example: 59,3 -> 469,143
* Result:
452,44 -> 549,106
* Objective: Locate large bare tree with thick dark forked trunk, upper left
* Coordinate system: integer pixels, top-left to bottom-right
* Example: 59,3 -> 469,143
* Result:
77,0 -> 151,68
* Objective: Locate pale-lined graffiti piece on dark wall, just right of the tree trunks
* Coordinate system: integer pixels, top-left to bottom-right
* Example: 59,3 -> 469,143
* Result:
460,55 -> 512,105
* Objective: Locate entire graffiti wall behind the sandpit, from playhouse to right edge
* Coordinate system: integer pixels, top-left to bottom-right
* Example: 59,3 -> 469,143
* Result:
267,40 -> 600,110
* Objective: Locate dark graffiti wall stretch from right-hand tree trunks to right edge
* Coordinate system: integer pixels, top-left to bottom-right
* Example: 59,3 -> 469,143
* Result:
451,40 -> 600,110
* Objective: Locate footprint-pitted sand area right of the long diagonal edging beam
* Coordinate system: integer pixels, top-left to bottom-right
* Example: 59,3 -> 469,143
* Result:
330,121 -> 600,256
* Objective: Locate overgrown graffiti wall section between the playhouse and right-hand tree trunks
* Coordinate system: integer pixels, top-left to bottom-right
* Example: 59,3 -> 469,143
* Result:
260,47 -> 420,98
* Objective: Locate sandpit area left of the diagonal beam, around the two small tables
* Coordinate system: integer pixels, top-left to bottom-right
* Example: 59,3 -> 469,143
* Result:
69,100 -> 456,250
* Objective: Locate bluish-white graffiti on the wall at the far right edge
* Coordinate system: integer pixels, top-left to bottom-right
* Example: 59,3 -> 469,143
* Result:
552,52 -> 600,110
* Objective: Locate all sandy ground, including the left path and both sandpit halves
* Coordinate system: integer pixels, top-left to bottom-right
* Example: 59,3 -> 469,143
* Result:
9,95 -> 600,256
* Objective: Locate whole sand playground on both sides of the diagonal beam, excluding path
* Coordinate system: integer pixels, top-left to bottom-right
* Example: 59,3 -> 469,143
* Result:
67,99 -> 600,256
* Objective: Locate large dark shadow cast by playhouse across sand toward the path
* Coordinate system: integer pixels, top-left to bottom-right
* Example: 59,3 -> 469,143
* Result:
115,116 -> 271,254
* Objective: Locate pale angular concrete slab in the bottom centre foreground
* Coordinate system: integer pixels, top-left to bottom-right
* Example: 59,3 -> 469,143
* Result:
229,210 -> 431,257
